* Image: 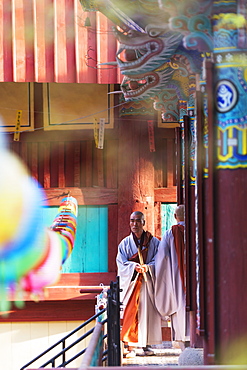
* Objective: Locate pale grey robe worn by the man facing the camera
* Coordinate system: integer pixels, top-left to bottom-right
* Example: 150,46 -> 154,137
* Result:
116,233 -> 162,347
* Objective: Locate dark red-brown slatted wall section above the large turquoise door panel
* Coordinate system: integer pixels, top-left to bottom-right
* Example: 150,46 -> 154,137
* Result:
11,140 -> 118,194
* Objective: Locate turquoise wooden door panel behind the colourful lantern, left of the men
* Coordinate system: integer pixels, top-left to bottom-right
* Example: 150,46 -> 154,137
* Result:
43,206 -> 108,273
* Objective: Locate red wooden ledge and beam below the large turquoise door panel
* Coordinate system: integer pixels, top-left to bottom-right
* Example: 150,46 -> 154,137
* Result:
0,272 -> 116,322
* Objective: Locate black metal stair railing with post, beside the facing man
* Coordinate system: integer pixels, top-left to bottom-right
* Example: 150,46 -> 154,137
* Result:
20,277 -> 121,370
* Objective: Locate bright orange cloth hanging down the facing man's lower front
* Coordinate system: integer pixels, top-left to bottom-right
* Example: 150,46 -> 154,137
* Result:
120,274 -> 143,343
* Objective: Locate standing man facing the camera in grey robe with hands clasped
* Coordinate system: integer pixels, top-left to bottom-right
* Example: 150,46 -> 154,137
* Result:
116,211 -> 162,357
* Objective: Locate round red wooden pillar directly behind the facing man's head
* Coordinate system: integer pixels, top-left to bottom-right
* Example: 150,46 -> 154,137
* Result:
118,116 -> 154,242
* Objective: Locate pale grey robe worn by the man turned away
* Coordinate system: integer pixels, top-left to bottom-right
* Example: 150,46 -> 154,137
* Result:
155,222 -> 189,341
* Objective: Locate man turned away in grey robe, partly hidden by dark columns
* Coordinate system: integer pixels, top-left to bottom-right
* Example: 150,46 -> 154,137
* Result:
155,204 -> 189,349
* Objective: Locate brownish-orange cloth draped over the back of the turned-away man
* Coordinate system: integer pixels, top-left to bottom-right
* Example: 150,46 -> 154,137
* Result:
172,225 -> 186,291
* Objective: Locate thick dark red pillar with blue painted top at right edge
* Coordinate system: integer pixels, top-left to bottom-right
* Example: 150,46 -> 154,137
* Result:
211,0 -> 247,365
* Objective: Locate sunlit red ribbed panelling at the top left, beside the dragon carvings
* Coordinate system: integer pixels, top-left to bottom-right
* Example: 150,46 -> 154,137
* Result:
0,0 -> 119,84
